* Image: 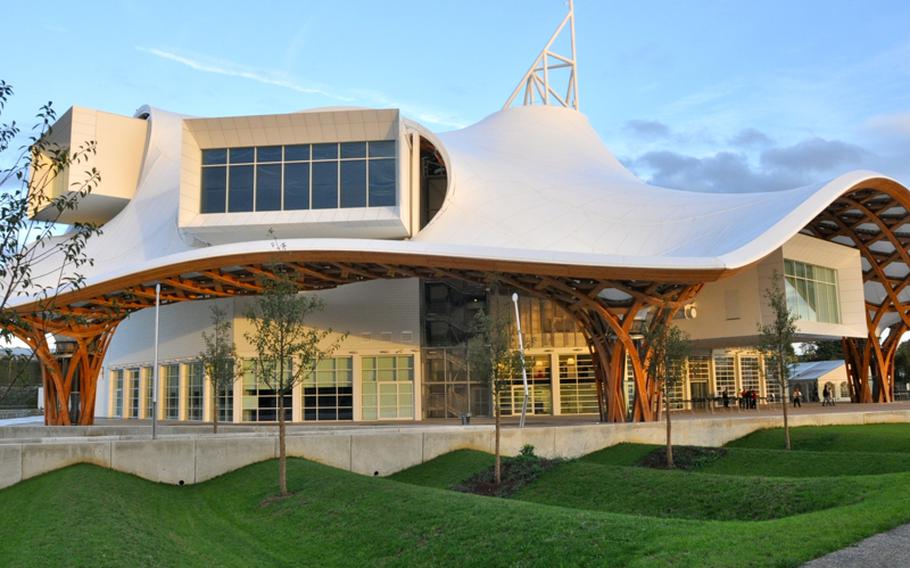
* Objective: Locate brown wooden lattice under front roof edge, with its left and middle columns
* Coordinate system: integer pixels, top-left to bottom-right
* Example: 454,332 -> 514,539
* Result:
14,251 -> 704,424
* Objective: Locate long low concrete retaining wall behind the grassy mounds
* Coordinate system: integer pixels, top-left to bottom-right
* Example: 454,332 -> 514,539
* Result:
0,410 -> 910,488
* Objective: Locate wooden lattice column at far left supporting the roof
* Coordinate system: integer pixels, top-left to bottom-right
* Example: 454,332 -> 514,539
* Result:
13,318 -> 121,426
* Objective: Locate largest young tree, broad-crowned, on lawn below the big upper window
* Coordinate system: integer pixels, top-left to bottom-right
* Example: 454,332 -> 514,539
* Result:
244,272 -> 347,496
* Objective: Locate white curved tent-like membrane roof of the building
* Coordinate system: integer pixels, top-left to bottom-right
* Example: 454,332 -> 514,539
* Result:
22,102 -> 908,303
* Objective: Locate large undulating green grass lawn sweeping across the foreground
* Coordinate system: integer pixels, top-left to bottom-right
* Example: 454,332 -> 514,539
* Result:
0,425 -> 910,566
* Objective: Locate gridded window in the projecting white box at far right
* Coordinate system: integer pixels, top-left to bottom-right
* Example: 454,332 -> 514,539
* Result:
784,259 -> 840,323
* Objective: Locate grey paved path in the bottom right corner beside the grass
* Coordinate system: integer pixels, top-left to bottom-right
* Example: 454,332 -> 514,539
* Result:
803,525 -> 910,568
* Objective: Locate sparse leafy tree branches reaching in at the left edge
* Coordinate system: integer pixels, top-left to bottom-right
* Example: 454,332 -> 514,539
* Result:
0,80 -> 101,418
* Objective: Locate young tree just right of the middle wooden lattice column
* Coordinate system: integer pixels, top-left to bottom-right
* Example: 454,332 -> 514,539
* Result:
646,312 -> 690,469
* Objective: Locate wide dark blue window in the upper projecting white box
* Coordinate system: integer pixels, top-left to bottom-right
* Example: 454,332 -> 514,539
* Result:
200,140 -> 398,213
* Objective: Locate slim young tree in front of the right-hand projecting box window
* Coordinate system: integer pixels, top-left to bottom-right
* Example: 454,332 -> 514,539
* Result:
758,271 -> 796,450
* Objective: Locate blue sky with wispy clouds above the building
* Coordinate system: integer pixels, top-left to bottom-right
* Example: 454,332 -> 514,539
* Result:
0,0 -> 910,191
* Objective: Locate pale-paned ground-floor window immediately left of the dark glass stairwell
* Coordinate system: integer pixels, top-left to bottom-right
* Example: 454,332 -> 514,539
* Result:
361,355 -> 414,420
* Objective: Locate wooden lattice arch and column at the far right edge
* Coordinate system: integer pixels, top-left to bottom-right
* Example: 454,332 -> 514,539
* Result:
805,180 -> 910,402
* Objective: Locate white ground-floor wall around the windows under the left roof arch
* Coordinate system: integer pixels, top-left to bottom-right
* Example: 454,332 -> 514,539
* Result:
95,278 -> 422,422
